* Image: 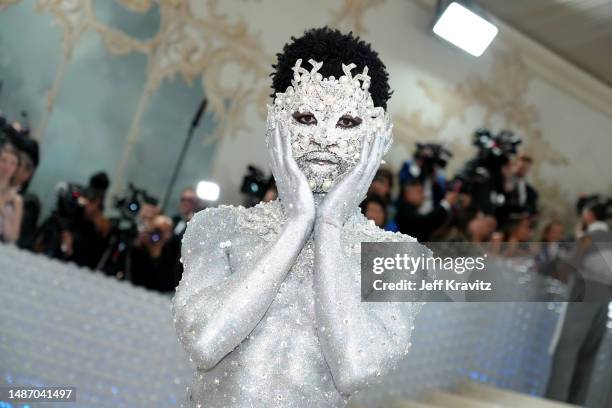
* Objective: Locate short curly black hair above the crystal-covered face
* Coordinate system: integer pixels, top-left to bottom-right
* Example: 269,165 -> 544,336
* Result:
270,27 -> 391,110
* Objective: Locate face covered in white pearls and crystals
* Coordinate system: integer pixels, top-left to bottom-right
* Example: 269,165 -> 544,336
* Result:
268,59 -> 390,193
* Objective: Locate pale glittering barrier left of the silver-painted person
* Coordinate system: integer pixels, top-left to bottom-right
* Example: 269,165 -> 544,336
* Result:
0,246 -> 193,408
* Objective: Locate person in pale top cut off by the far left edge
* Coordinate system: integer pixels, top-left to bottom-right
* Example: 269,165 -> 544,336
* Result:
0,142 -> 23,244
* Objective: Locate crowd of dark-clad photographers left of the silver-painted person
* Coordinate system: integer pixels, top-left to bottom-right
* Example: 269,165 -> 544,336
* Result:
0,111 -> 203,292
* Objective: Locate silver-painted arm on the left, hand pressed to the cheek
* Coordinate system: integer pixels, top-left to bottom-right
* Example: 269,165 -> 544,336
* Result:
173,114 -> 315,370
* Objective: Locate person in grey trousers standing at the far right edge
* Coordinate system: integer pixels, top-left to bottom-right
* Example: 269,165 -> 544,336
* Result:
546,195 -> 612,406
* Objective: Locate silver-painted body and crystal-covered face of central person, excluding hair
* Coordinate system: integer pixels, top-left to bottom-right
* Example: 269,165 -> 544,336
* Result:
173,29 -> 422,408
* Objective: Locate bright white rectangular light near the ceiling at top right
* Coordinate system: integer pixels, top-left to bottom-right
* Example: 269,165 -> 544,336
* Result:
433,2 -> 498,57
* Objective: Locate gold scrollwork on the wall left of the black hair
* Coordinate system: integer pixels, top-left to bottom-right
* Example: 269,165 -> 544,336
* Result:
26,0 -> 272,198
